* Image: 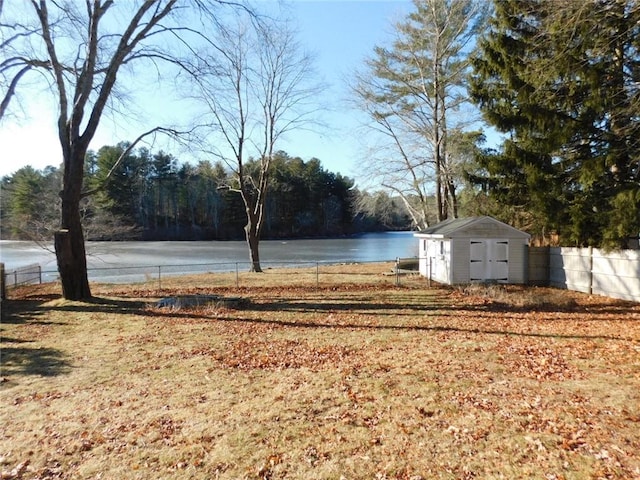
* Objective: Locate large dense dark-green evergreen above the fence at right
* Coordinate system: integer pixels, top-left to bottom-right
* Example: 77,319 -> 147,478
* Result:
472,0 -> 640,247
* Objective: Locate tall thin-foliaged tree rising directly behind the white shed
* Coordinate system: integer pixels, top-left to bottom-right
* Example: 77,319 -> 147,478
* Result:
353,0 -> 486,228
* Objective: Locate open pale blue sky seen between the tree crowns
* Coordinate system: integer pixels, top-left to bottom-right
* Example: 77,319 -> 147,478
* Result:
0,0 -> 412,180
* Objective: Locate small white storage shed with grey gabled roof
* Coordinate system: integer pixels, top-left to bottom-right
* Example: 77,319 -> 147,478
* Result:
414,217 -> 531,285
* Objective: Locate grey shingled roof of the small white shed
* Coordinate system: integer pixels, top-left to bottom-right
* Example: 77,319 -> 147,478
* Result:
415,216 -> 531,239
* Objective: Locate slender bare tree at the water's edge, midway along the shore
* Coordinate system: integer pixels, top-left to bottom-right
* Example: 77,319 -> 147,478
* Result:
191,16 -> 320,272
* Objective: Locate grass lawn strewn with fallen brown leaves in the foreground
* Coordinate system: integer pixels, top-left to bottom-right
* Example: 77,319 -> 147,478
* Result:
0,264 -> 640,480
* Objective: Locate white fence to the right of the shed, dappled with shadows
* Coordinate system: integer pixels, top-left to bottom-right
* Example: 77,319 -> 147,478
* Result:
544,247 -> 640,302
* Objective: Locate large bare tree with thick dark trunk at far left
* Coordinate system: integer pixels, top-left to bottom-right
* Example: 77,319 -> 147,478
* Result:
0,0 -> 246,299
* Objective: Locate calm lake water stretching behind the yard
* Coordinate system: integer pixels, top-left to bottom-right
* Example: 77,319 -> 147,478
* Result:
0,232 -> 418,282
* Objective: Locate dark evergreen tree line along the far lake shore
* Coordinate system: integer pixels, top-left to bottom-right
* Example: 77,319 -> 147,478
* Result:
0,143 -> 411,241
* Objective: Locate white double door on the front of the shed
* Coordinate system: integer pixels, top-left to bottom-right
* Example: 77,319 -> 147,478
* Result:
469,238 -> 509,282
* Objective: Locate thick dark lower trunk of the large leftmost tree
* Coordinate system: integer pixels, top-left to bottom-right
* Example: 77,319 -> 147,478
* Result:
54,152 -> 91,300
